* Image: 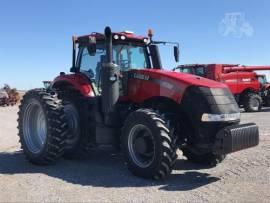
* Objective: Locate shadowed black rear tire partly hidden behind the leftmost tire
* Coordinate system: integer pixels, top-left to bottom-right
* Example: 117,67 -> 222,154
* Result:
58,89 -> 91,159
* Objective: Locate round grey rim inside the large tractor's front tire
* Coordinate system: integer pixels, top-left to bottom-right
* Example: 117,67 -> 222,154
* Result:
128,124 -> 155,168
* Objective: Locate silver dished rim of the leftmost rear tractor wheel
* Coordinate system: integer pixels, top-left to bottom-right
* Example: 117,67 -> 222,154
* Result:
23,100 -> 47,154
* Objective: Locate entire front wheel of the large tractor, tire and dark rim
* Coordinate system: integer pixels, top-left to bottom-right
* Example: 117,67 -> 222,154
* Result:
121,109 -> 177,179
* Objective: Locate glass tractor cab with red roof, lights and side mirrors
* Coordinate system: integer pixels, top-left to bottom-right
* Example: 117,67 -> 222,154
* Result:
71,30 -> 179,91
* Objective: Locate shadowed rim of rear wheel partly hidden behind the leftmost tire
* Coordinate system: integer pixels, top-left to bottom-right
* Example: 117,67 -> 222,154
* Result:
64,103 -> 80,149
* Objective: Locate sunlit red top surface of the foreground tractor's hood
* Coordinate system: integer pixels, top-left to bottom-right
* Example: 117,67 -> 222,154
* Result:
136,69 -> 227,88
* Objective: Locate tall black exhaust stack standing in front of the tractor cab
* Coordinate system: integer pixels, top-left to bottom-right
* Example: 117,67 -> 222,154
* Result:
101,27 -> 120,117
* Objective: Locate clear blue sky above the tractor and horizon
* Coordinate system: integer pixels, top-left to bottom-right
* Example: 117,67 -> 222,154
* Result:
0,0 -> 270,89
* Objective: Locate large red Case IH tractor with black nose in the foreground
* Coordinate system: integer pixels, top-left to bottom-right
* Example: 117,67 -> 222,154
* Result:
18,27 -> 259,179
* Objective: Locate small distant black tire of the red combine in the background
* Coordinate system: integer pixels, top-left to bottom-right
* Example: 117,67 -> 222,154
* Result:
243,92 -> 262,112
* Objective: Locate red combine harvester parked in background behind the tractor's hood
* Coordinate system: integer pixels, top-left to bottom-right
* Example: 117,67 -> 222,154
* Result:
174,64 -> 270,112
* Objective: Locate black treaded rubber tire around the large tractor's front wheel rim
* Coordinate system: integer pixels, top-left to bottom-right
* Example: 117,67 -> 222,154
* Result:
121,109 -> 177,180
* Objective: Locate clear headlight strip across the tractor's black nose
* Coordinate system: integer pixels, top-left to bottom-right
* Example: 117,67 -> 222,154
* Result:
201,113 -> 240,122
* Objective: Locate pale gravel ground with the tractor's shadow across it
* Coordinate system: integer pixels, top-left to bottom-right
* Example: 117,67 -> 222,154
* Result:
0,107 -> 270,202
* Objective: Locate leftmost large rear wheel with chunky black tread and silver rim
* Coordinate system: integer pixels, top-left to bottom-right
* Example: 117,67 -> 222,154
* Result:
18,89 -> 68,165
